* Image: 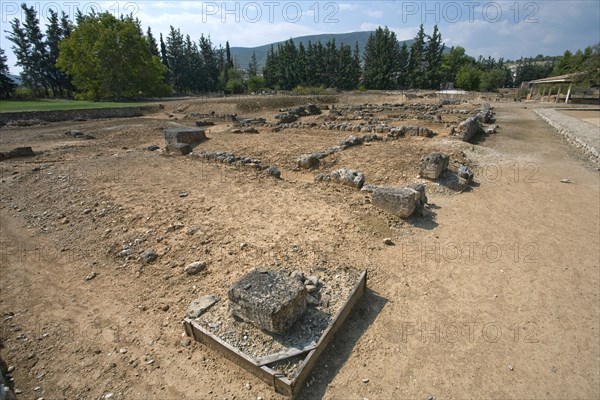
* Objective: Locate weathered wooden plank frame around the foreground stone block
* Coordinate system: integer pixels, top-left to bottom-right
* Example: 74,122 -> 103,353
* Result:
183,271 -> 367,397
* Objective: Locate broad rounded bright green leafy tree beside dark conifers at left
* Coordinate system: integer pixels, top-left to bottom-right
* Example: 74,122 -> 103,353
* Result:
57,12 -> 168,100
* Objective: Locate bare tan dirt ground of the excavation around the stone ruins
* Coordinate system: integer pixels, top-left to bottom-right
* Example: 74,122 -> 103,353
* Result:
0,96 -> 600,399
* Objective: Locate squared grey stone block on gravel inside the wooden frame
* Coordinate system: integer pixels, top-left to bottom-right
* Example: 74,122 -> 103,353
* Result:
228,270 -> 306,334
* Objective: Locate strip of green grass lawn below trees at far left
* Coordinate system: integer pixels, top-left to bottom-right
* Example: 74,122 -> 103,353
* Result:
0,100 -> 147,112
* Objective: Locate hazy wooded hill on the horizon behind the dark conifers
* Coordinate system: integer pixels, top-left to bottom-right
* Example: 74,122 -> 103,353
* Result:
231,31 -> 413,70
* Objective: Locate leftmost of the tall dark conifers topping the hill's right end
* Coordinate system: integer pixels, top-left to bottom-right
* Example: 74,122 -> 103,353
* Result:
363,27 -> 401,89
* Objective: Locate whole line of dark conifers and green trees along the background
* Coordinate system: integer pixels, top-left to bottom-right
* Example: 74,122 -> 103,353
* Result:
0,4 -> 600,100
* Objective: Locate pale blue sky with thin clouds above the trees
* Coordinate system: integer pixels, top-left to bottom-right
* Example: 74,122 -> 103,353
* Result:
0,0 -> 600,72
